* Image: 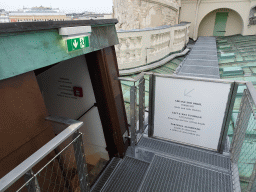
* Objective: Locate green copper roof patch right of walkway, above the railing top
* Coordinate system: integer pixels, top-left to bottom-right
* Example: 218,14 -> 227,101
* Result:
217,35 -> 256,84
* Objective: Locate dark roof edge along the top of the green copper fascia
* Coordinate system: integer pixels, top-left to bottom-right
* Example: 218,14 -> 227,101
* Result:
0,19 -> 118,34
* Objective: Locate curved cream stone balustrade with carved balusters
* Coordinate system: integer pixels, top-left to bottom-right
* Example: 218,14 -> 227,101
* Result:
116,23 -> 190,70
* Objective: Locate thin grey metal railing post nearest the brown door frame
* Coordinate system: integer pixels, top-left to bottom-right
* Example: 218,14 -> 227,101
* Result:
130,85 -> 137,151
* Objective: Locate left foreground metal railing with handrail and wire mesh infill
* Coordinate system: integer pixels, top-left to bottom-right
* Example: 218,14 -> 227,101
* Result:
0,116 -> 90,192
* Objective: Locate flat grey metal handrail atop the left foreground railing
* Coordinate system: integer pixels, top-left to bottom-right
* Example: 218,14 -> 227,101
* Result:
0,116 -> 83,192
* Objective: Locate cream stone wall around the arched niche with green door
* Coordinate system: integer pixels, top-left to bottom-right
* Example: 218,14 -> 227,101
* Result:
180,0 -> 256,40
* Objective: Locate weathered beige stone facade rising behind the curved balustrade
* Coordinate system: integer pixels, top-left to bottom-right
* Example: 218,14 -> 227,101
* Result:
113,0 -> 181,30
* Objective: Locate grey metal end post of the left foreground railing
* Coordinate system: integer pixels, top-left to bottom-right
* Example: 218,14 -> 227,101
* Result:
73,131 -> 90,192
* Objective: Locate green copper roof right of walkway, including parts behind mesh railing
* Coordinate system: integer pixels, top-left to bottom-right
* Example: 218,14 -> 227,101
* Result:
217,35 -> 256,182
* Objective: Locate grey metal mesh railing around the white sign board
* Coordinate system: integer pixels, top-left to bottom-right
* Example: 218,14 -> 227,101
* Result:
118,72 -> 256,192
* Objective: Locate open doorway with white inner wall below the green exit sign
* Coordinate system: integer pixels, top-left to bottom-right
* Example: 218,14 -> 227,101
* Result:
37,55 -> 110,184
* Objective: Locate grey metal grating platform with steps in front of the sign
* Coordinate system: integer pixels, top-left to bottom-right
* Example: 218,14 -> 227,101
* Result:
91,137 -> 233,192
